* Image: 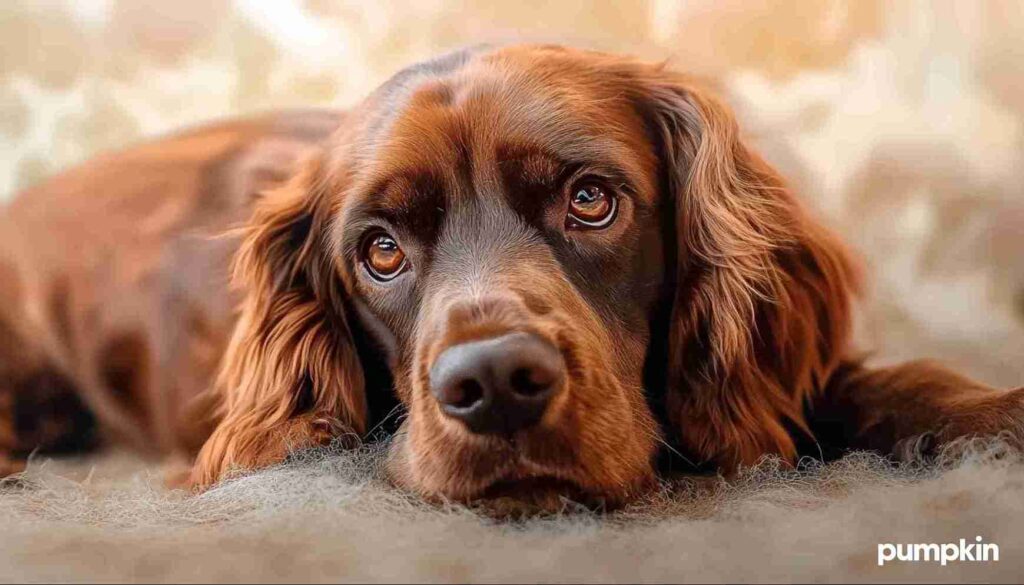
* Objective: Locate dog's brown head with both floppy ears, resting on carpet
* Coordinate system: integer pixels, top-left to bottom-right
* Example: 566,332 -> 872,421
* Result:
190,46 -> 852,505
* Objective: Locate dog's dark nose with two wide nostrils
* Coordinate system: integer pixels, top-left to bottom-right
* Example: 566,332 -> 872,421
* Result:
430,333 -> 565,434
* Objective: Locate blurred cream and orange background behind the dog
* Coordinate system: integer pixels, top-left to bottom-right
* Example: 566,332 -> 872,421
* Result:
0,0 -> 1024,386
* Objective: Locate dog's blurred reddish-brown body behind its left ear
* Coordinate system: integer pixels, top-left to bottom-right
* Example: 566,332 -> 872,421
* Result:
0,112 -> 342,476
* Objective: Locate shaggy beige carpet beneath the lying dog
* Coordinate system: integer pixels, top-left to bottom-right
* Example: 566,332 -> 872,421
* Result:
0,444 -> 1024,582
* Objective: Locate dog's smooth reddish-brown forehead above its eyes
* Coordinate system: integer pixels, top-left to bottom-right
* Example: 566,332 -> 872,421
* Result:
346,51 -> 656,219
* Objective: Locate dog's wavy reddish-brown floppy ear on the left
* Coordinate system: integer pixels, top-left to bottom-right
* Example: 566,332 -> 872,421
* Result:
190,152 -> 367,488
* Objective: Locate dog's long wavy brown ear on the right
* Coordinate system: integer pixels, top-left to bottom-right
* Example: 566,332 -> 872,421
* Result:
638,70 -> 858,469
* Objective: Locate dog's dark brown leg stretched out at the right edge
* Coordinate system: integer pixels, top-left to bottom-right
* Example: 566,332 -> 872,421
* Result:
810,362 -> 1024,460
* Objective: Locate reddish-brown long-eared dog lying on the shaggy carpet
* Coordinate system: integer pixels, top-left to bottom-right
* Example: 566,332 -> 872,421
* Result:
0,45 -> 1024,509
